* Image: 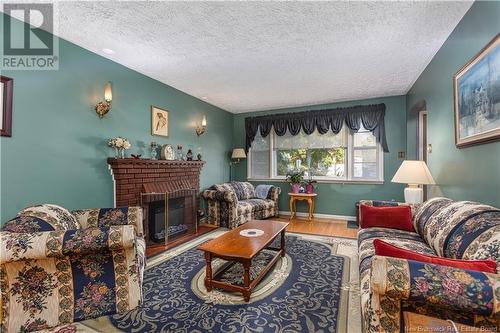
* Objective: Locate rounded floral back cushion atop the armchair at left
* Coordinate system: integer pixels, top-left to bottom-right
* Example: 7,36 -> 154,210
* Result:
17,204 -> 80,230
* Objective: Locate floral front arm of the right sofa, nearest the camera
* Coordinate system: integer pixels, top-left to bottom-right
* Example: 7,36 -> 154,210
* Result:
370,256 -> 500,317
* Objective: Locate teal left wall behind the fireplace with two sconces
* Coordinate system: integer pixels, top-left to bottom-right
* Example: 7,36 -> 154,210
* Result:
0,14 -> 233,222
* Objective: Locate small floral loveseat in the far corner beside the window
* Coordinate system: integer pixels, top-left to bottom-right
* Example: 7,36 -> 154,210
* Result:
203,182 -> 281,229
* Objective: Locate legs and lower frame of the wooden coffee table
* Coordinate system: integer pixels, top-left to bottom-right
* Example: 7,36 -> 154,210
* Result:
201,231 -> 285,302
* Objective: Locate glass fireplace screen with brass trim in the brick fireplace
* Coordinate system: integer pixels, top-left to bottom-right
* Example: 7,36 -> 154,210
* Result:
141,189 -> 197,245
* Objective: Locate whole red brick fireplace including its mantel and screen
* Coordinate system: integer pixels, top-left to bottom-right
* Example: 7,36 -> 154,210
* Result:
108,158 -> 205,246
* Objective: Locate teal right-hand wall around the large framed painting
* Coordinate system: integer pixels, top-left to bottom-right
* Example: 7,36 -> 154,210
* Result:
407,1 -> 500,206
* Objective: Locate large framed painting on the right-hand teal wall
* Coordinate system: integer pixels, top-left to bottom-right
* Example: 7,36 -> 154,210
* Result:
453,34 -> 500,148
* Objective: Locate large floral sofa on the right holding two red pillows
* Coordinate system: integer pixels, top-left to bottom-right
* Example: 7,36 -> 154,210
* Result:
358,198 -> 500,332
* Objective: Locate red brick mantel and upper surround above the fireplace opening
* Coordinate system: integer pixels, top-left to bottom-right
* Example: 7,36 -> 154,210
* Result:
108,158 -> 205,207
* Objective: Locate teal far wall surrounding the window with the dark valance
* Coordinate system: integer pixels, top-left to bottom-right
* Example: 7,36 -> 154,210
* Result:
233,96 -> 406,216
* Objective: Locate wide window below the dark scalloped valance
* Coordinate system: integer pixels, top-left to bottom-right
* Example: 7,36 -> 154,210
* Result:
248,126 -> 383,181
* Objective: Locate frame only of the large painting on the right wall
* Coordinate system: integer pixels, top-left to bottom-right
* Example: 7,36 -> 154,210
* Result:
453,33 -> 500,149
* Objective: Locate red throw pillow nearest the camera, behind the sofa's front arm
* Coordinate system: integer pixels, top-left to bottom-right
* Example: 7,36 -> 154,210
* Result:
373,239 -> 497,273
